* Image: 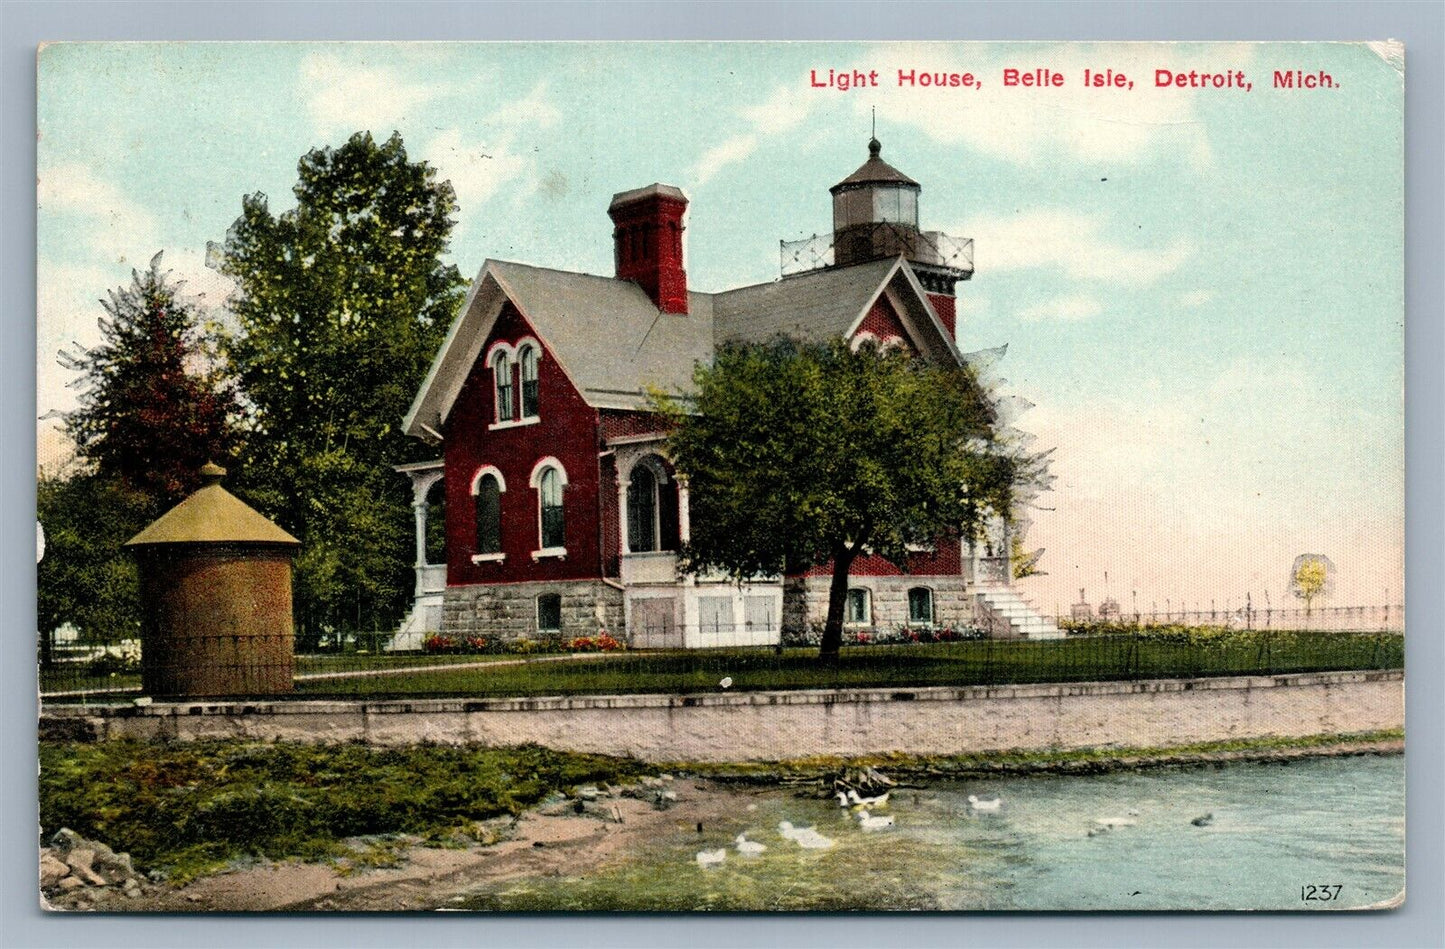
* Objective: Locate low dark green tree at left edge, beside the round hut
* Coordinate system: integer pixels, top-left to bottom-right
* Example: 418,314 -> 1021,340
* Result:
36,471 -> 156,666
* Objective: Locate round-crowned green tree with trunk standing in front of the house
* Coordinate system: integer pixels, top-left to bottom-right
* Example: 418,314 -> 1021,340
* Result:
653,341 -> 1029,662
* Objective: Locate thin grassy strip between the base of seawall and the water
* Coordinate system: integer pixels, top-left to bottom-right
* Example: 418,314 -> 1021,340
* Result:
679,728 -> 1405,784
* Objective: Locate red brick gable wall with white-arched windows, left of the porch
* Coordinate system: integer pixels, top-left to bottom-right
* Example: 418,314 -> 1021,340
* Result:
442,303 -> 601,586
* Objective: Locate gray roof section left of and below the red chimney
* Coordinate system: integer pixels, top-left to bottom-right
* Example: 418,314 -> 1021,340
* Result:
488,260 -> 712,409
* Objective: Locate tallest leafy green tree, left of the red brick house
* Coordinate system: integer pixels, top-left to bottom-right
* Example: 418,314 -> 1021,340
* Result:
217,133 -> 465,636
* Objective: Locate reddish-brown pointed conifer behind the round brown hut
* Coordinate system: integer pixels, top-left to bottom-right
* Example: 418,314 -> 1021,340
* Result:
61,254 -> 238,507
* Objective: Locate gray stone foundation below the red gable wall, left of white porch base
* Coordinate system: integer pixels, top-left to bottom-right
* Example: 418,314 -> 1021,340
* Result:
442,581 -> 623,640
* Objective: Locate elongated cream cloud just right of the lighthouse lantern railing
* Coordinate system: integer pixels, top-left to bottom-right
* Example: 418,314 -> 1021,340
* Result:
951,208 -> 1194,286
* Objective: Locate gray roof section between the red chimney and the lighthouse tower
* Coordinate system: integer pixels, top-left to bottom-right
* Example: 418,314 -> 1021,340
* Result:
712,259 -> 897,342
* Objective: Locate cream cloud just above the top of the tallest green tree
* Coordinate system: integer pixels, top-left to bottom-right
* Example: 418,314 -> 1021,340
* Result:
299,52 -> 444,139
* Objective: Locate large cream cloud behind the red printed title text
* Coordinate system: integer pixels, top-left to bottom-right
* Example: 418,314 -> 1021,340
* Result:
854,43 -> 1254,168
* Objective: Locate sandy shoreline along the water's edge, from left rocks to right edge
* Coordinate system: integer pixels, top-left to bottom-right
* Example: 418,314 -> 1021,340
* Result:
42,732 -> 1405,913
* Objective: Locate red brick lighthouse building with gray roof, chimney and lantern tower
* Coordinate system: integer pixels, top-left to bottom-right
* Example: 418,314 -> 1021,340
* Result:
394,140 -> 1058,649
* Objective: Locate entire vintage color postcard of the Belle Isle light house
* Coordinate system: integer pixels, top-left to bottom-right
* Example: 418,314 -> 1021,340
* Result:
36,40 -> 1405,913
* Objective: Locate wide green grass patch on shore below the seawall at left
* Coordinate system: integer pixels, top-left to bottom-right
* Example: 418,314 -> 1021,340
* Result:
40,741 -> 652,883
